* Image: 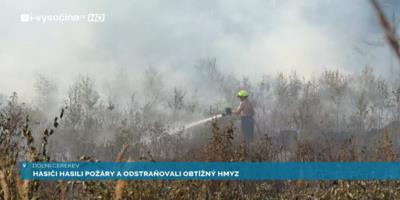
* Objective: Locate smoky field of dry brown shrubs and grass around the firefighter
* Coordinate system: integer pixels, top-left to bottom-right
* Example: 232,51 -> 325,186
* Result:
0,61 -> 400,199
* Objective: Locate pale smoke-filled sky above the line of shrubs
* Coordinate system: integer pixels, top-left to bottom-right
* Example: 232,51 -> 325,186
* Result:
0,0 -> 399,101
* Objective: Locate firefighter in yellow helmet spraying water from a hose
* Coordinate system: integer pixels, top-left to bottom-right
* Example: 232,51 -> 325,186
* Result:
233,90 -> 254,142
